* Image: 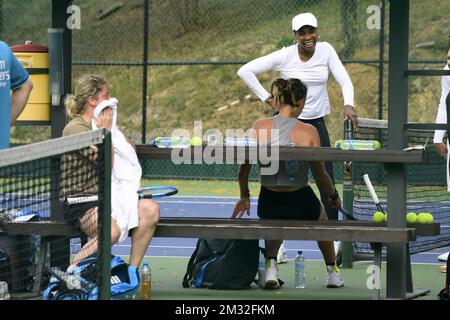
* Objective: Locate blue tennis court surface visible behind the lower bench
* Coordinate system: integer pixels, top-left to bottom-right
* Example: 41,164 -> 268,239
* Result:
112,197 -> 450,264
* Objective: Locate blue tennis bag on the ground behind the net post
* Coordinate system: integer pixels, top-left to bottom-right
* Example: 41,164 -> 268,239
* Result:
43,255 -> 140,300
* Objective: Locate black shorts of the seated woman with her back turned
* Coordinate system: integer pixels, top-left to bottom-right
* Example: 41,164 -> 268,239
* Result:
257,186 -> 321,220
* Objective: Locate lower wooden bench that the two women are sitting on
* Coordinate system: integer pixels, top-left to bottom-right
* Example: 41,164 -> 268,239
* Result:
5,218 -> 440,298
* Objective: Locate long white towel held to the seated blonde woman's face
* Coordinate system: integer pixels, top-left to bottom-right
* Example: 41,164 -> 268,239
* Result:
92,98 -> 142,242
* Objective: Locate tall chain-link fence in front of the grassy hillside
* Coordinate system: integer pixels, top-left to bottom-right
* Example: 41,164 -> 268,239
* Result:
0,0 -> 450,180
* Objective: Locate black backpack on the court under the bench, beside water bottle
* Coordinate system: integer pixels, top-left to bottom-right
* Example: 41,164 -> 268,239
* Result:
183,239 -> 259,290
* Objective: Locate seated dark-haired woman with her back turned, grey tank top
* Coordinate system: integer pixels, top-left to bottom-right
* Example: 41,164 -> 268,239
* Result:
232,79 -> 344,289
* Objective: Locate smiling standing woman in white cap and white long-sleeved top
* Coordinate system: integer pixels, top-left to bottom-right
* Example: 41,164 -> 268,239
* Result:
237,13 -> 358,220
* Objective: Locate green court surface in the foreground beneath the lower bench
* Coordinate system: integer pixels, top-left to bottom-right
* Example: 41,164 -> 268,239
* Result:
136,257 -> 445,300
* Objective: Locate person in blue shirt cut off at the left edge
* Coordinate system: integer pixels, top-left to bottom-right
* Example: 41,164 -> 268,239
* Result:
0,41 -> 33,149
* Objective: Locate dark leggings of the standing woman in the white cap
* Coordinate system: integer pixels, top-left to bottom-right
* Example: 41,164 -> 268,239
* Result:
299,117 -> 339,220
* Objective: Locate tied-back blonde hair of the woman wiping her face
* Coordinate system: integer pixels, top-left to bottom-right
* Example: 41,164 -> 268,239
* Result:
64,74 -> 106,119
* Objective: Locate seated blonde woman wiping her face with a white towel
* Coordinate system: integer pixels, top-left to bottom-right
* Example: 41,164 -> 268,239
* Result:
62,74 -> 159,268
